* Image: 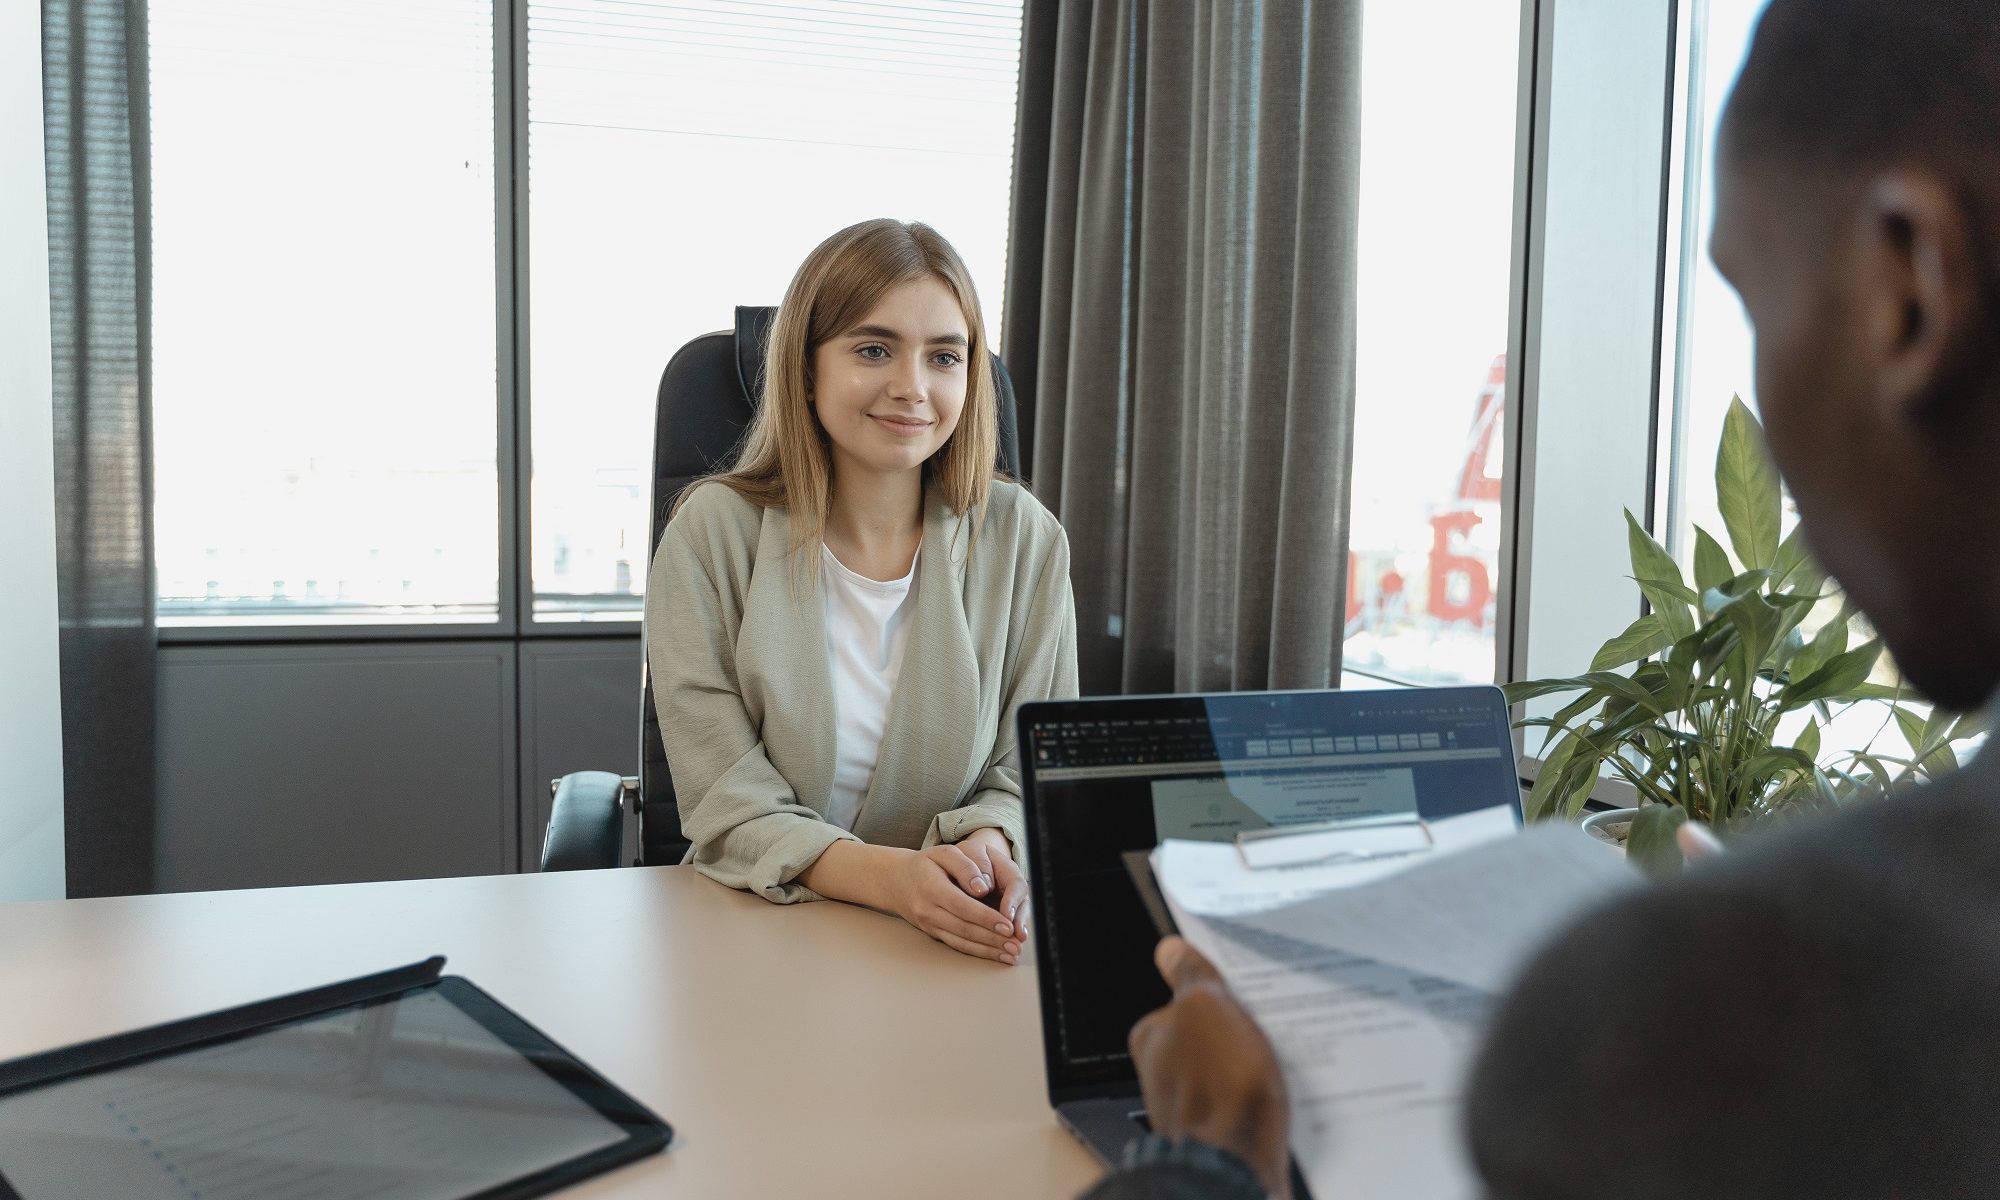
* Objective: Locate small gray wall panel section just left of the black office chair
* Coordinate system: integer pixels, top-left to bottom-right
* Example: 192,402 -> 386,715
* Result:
520,634 -> 640,870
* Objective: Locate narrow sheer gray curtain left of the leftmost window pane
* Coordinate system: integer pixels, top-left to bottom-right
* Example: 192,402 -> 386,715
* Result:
42,0 -> 154,896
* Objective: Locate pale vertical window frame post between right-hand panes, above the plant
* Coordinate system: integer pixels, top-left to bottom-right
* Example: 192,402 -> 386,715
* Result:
1494,0 -> 1692,740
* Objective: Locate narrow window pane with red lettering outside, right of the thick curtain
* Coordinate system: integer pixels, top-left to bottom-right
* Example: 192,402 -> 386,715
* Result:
1344,0 -> 1520,686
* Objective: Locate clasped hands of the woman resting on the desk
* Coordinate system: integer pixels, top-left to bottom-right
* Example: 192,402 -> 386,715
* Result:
892,828 -> 1028,966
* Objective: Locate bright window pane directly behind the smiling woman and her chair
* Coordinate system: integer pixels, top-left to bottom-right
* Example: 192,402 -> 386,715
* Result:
528,0 -> 1020,620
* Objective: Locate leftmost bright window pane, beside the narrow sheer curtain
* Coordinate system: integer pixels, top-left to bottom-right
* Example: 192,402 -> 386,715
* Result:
148,0 -> 498,626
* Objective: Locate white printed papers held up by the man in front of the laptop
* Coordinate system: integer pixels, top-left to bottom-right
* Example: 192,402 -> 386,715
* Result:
1152,808 -> 1638,1200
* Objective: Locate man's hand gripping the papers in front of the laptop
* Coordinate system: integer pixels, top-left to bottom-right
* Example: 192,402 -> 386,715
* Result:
1132,938 -> 1292,1200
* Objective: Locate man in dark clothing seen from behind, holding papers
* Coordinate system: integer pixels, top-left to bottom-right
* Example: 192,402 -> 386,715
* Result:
1090,0 -> 2000,1200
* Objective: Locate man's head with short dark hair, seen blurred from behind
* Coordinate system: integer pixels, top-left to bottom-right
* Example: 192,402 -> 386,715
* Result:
1712,0 -> 2000,708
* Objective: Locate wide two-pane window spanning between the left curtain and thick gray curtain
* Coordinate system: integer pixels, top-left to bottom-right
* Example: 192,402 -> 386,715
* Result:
148,0 -> 1020,628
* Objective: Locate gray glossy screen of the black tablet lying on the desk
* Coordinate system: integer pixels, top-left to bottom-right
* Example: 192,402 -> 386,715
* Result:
0,980 -> 628,1200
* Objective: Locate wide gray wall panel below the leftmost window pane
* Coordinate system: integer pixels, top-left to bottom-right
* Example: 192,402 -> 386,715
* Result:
156,642 -> 520,892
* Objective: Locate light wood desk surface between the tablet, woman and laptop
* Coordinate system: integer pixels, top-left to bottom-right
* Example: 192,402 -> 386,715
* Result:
0,866 -> 1098,1200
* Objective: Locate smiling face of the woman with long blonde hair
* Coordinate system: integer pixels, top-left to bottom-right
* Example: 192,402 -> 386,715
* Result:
810,278 -> 970,480
